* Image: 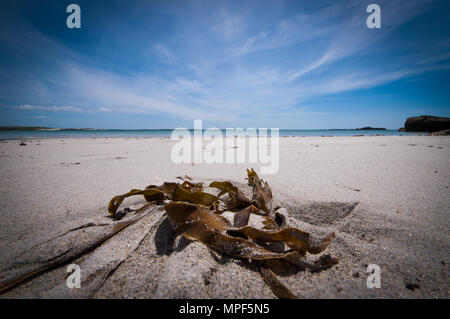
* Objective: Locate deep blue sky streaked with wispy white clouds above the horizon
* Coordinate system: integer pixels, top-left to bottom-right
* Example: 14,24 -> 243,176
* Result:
0,0 -> 450,129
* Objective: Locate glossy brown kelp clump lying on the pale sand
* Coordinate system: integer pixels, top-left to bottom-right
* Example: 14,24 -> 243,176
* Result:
108,169 -> 337,298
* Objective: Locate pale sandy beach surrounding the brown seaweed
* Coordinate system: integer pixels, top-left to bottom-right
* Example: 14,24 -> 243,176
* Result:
0,136 -> 450,298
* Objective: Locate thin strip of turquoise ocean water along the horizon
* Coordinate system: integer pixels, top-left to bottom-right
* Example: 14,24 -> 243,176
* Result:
0,129 -> 418,140
